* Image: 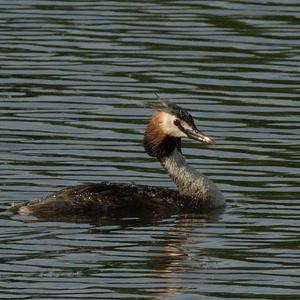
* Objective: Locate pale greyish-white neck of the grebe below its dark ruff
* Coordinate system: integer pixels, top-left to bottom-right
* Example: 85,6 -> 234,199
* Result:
160,148 -> 225,207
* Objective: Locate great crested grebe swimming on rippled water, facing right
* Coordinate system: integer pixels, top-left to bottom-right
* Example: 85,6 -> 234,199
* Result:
10,100 -> 225,217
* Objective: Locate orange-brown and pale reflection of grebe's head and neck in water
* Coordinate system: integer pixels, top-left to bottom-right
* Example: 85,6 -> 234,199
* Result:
149,210 -> 223,297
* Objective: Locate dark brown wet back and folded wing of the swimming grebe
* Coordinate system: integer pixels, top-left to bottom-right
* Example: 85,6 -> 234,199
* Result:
10,182 -> 181,217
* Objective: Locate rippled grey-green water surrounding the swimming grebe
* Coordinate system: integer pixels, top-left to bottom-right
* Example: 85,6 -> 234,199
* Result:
0,0 -> 300,300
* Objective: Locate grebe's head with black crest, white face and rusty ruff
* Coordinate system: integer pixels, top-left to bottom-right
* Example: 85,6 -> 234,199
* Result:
144,100 -> 214,157
